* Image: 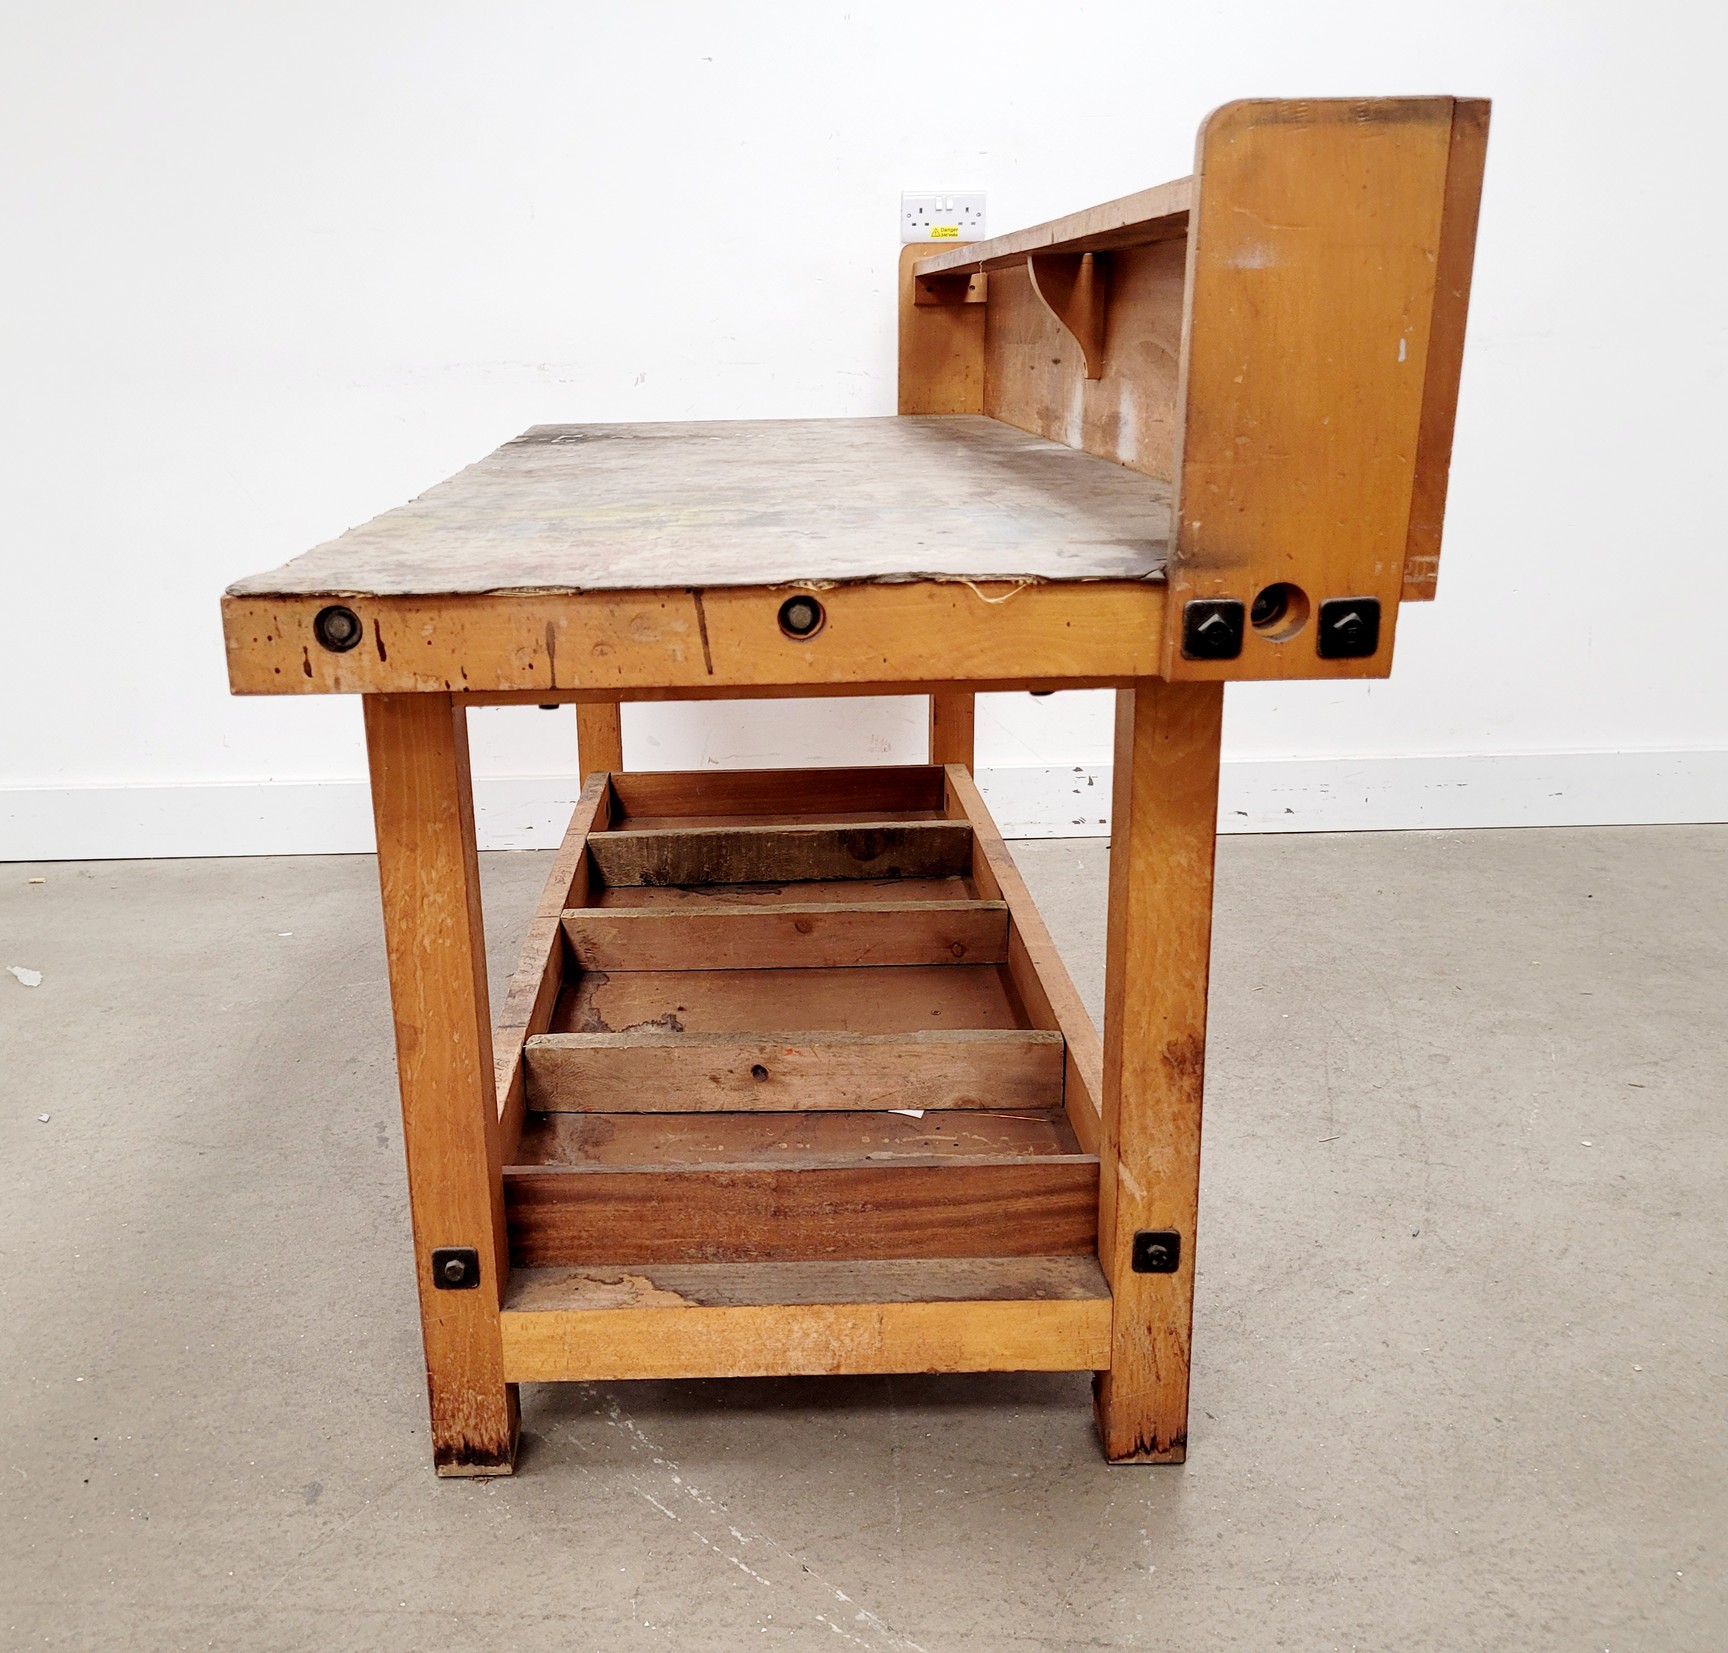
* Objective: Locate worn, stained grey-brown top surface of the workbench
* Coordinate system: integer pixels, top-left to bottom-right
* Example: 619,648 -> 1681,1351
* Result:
230,415 -> 1170,596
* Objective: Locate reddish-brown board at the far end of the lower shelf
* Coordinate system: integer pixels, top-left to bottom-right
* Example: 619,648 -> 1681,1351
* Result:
612,763 -> 942,827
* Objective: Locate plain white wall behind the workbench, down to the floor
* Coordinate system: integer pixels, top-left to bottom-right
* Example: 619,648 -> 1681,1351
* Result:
0,0 -> 1728,857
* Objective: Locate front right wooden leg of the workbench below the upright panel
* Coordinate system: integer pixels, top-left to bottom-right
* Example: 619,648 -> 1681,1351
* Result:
1097,679 -> 1223,1463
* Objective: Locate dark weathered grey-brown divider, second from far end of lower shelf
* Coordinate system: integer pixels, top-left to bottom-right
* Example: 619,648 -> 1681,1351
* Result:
588,820 -> 971,884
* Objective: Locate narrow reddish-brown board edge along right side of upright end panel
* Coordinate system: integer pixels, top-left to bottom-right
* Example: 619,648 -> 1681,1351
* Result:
1403,98 -> 1490,603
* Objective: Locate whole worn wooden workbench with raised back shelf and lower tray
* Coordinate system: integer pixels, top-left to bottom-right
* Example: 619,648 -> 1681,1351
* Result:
223,98 -> 1486,1475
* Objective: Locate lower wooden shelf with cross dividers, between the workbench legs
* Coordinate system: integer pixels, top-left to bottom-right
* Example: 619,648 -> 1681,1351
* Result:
496,767 -> 1111,1382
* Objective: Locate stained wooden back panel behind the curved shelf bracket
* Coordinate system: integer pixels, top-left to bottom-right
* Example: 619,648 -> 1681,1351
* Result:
985,240 -> 1185,480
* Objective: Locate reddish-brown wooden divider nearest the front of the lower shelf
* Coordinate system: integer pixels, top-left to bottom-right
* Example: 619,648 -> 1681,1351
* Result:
505,1154 -> 1099,1268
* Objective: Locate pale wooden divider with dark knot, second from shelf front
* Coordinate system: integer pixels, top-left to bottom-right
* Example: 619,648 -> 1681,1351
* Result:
527,1028 -> 1063,1114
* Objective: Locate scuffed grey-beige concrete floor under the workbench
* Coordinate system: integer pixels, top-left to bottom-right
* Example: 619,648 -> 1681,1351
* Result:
0,827 -> 1728,1653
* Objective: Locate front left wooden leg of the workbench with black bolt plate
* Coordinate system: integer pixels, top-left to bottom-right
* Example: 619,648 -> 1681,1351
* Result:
365,694 -> 517,1475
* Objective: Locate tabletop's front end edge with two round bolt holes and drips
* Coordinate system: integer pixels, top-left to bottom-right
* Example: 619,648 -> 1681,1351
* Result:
223,573 -> 1165,705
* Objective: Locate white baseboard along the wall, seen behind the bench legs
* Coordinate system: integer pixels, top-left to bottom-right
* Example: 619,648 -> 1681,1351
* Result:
0,750 -> 1728,860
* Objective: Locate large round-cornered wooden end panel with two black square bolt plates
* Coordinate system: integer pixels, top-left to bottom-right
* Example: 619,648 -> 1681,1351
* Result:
1158,98 -> 1453,681
